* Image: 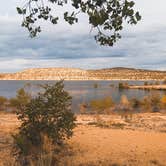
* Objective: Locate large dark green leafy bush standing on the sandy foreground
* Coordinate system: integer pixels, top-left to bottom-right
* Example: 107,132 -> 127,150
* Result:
13,81 -> 75,156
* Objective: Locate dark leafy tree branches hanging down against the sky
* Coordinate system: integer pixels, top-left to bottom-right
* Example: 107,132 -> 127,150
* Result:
17,0 -> 141,46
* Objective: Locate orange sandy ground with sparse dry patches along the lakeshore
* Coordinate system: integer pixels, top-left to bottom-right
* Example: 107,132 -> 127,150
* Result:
0,113 -> 166,166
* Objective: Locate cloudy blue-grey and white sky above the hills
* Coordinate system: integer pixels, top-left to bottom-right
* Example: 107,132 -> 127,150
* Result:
0,0 -> 166,72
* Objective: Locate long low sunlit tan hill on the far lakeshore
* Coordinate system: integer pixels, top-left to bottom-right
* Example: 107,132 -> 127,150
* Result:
0,67 -> 166,80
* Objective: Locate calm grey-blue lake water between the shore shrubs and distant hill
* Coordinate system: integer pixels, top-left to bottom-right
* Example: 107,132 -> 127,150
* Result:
0,81 -> 166,112
